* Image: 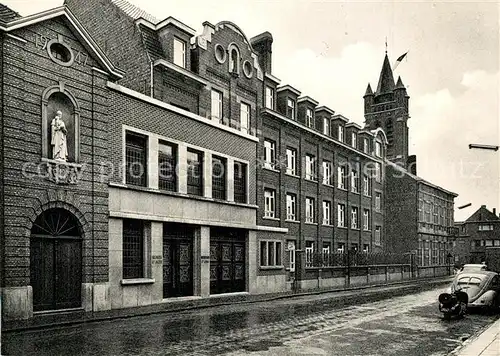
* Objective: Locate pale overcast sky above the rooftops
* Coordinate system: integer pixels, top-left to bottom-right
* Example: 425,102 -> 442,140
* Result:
4,0 -> 500,221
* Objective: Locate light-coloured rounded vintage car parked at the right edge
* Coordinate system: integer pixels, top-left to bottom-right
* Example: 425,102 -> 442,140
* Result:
451,271 -> 500,310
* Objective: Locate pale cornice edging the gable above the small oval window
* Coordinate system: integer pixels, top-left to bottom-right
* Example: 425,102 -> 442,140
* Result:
0,6 -> 124,78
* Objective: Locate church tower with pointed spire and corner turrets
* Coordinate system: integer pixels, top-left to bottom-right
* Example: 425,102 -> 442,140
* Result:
363,53 -> 410,168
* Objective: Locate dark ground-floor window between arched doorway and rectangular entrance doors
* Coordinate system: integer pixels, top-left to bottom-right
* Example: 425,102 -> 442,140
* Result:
123,219 -> 144,279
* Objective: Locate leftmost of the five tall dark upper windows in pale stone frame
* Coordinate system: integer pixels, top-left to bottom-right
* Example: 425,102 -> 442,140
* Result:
125,132 -> 148,187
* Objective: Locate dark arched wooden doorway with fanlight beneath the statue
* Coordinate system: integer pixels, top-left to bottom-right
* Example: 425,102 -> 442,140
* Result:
30,208 -> 82,311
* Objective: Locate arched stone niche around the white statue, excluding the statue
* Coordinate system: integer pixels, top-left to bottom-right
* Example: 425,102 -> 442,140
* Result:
42,83 -> 80,163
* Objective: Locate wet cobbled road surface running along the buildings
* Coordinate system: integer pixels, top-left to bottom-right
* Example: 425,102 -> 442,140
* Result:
2,288 -> 496,356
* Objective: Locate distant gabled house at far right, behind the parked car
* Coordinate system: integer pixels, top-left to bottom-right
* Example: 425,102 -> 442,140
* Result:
453,205 -> 500,264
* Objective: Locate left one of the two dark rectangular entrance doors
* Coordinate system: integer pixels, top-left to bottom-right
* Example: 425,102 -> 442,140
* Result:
163,224 -> 194,298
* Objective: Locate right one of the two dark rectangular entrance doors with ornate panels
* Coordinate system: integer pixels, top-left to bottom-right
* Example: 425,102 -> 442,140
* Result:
210,228 -> 246,294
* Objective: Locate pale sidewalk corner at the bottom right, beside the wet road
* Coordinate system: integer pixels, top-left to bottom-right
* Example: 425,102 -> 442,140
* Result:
451,319 -> 500,356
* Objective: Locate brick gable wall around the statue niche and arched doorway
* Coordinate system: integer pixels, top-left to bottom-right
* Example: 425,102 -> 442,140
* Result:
2,18 -> 108,286
